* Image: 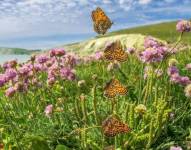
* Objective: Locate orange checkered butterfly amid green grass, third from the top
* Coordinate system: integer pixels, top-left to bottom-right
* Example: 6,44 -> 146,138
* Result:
104,79 -> 128,98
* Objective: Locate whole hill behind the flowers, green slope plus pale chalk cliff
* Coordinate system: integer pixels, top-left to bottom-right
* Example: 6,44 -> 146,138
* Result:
61,22 -> 191,55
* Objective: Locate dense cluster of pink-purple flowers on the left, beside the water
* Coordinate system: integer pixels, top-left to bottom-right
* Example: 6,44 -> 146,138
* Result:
0,49 -> 78,97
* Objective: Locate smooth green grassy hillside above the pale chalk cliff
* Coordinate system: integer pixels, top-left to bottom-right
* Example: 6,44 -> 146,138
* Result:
105,21 -> 191,44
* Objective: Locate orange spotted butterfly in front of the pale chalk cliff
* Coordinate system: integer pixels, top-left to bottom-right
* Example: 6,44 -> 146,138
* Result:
104,41 -> 128,62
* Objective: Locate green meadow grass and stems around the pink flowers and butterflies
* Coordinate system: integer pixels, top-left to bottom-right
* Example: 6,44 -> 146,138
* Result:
0,21 -> 191,150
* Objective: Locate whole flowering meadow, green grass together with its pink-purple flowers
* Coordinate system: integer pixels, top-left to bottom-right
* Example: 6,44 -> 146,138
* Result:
0,21 -> 191,150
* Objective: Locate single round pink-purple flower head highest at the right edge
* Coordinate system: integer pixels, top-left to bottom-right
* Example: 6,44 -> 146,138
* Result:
176,20 -> 191,32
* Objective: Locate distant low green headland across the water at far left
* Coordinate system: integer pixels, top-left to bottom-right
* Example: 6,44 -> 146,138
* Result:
0,47 -> 40,55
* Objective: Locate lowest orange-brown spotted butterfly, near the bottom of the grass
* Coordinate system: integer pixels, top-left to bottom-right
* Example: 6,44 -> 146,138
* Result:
102,115 -> 131,137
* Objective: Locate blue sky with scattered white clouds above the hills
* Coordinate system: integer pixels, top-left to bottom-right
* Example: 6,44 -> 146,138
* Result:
0,0 -> 191,49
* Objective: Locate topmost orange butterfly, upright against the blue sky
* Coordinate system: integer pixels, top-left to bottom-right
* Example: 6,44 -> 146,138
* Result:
91,7 -> 113,35
